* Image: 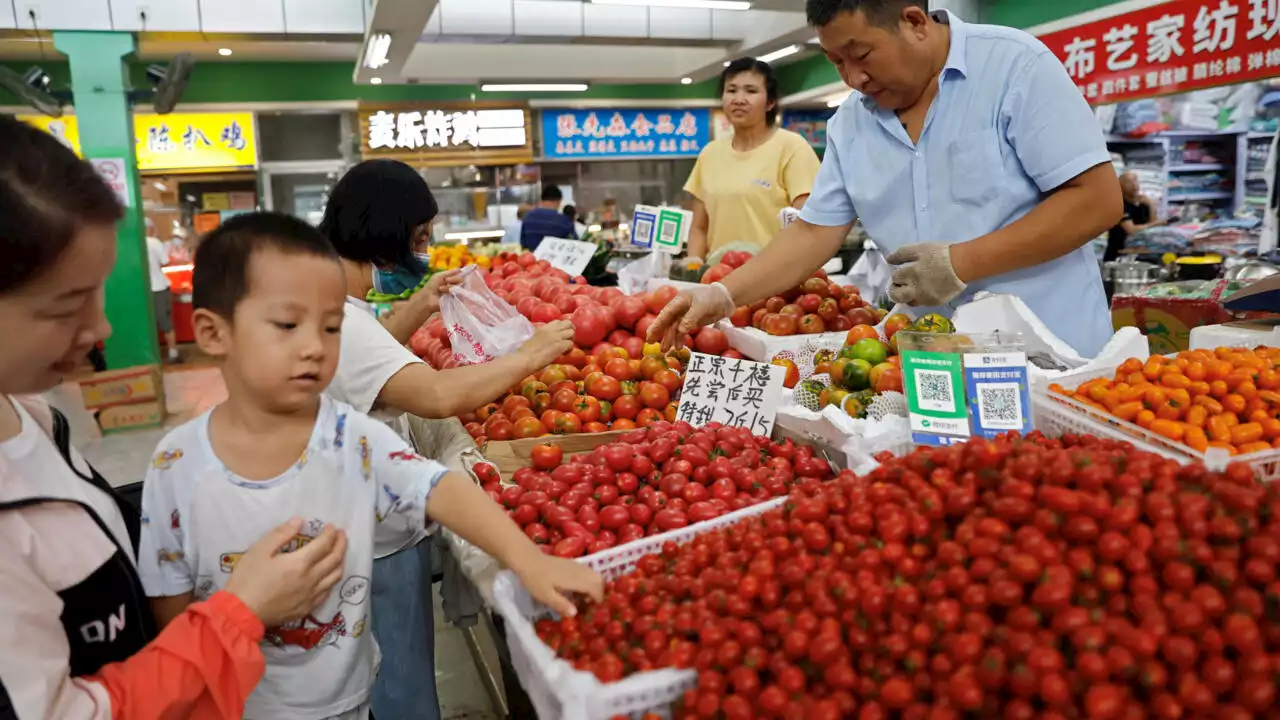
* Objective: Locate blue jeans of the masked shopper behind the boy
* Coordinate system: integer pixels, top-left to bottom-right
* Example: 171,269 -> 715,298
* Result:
372,538 -> 440,720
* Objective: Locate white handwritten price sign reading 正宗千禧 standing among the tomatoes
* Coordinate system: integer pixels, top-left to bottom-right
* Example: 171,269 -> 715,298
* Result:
676,352 -> 786,436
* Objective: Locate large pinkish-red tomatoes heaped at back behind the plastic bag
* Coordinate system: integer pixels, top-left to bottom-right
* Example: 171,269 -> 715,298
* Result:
408,254 -> 741,369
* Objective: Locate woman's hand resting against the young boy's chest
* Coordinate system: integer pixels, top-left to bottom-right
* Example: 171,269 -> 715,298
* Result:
227,518 -> 347,628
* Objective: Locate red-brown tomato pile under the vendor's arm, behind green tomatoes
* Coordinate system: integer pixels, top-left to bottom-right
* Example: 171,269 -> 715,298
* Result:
727,270 -> 884,336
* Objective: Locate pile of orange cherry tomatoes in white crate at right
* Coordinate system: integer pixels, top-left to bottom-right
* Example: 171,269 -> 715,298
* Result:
1050,347 -> 1280,455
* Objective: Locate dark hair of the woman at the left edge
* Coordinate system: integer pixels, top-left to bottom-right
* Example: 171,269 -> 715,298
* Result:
0,117 -> 124,293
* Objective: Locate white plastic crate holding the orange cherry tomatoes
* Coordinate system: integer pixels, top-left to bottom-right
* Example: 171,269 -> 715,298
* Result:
1032,356 -> 1280,482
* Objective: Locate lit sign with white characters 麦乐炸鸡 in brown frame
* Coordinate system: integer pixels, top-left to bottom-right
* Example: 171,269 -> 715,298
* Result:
360,104 -> 534,165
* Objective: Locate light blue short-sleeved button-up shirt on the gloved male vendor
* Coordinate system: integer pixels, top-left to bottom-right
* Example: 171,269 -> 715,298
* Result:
800,9 -> 1111,357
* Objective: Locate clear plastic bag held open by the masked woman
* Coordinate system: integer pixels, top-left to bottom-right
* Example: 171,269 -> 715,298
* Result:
440,265 -> 534,365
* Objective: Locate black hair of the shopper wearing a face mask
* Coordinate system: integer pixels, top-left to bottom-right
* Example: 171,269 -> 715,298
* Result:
320,160 -> 440,273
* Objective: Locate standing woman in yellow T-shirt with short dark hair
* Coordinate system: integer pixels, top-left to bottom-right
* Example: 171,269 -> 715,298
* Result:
685,58 -> 819,260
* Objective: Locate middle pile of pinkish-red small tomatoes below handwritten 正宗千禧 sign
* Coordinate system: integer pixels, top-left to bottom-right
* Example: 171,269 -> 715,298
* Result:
481,420 -> 831,557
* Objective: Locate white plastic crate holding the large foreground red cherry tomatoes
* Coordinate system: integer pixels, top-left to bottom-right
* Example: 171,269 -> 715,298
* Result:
493,497 -> 787,720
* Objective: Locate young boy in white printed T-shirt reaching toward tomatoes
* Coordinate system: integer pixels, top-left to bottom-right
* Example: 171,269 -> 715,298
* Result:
138,213 -> 603,720
